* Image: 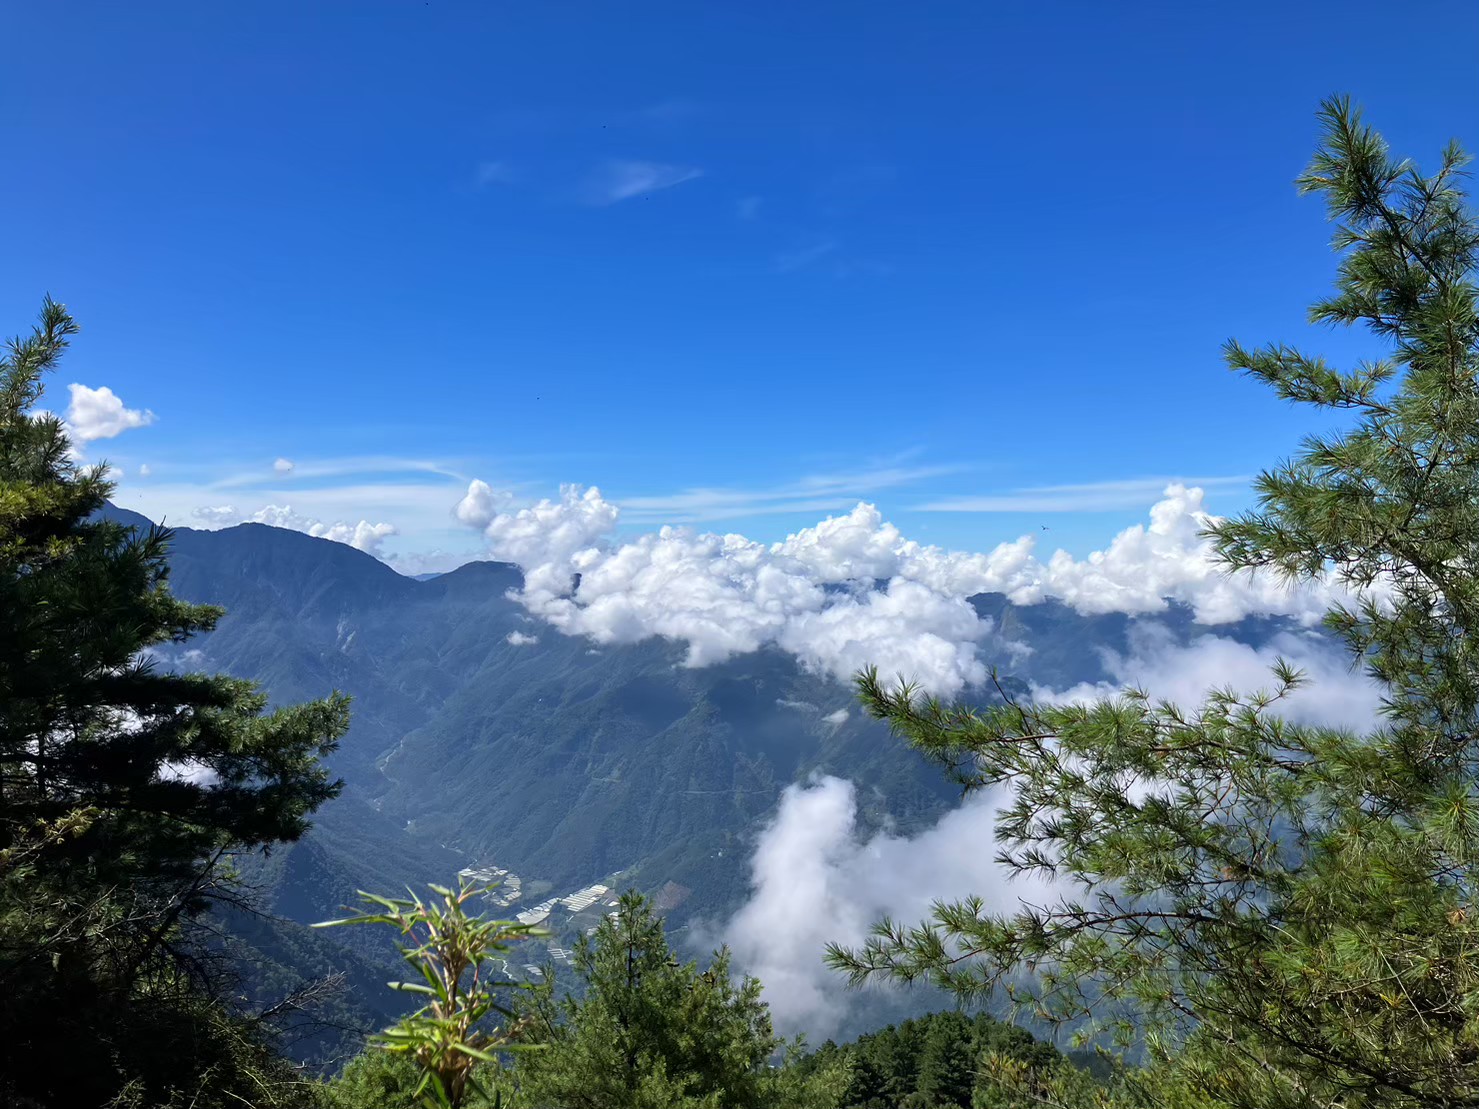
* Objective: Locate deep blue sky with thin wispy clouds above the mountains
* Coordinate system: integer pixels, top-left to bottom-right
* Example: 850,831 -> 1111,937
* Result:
0,0 -> 1479,566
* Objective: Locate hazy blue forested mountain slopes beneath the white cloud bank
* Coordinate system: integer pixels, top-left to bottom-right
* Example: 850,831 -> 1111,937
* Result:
98,509 -> 1325,1052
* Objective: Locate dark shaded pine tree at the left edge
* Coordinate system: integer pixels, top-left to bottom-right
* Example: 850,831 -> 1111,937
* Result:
0,299 -> 348,1108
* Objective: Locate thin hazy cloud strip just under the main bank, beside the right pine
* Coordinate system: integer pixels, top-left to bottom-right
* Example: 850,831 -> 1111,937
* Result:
1032,623 -> 1381,732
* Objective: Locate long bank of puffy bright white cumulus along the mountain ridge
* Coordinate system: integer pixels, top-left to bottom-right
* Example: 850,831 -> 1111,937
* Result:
457,482 -> 1344,695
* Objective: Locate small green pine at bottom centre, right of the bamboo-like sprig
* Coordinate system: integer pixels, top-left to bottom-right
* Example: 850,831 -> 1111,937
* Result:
515,893 -> 784,1109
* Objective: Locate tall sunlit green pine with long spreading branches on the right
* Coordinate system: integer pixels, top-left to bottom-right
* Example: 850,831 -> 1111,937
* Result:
831,99 -> 1479,1108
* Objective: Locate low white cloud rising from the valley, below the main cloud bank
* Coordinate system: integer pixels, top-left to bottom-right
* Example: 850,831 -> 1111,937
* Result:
722,778 -> 1053,1038
